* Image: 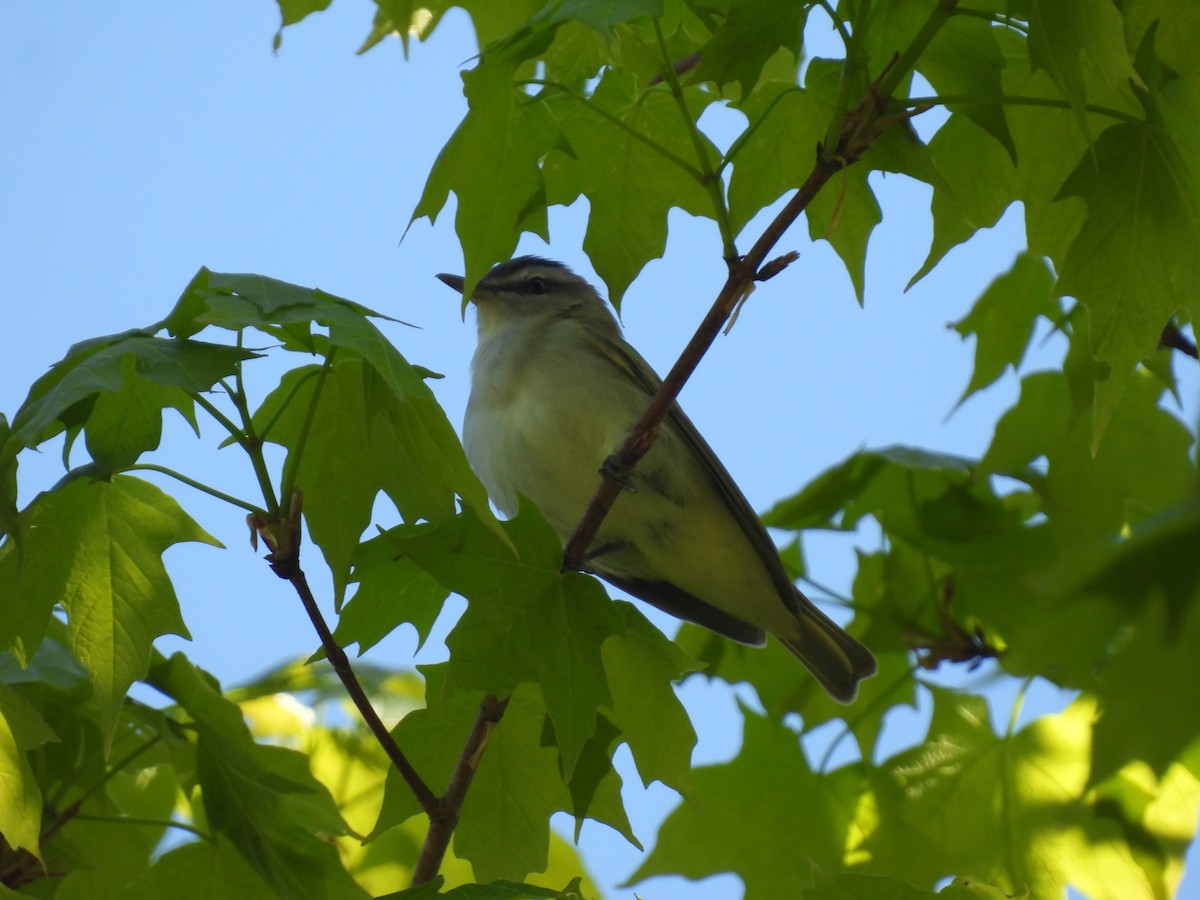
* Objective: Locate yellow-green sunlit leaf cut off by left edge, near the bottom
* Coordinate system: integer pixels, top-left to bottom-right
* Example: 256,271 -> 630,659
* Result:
0,684 -> 59,856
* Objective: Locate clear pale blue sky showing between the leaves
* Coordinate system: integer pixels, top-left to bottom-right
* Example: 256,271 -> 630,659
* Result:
0,0 -> 1196,900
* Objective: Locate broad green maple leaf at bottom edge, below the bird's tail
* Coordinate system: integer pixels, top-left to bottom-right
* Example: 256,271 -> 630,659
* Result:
630,710 -> 862,900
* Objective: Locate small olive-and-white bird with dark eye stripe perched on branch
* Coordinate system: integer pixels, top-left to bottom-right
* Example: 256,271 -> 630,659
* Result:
438,257 -> 875,703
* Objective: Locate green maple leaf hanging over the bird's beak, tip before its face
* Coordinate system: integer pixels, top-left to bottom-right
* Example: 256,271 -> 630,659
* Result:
409,55 -> 554,292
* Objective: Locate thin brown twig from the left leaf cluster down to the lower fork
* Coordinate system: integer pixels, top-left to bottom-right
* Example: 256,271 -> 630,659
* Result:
254,501 -> 440,817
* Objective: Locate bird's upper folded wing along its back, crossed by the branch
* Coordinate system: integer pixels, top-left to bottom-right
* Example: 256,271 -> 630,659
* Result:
595,341 -> 803,619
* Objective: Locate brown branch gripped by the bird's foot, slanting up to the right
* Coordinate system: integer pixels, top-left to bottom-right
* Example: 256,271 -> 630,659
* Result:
563,70 -> 919,569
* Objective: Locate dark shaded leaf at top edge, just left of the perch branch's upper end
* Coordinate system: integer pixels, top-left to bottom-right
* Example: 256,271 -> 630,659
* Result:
689,0 -> 811,97
